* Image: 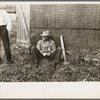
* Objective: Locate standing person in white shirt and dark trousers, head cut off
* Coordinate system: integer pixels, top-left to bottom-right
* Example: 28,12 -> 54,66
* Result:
0,6 -> 14,64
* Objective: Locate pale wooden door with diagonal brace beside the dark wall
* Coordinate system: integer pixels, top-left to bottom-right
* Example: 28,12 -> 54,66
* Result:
16,5 -> 30,48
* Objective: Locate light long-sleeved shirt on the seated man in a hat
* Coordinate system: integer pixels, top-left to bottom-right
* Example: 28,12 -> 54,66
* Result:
36,40 -> 56,53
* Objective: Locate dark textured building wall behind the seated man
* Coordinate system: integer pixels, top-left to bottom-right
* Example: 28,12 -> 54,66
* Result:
30,4 -> 100,48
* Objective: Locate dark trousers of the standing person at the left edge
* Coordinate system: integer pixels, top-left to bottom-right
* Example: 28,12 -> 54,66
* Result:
0,25 -> 11,62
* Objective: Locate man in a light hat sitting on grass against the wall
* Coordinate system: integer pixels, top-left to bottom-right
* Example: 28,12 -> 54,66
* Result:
31,30 -> 61,66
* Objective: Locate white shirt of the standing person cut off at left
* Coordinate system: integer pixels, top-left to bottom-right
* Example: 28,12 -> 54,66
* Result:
0,10 -> 12,31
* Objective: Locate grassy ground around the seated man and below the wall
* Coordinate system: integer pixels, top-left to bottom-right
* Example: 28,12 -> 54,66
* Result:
0,12 -> 100,82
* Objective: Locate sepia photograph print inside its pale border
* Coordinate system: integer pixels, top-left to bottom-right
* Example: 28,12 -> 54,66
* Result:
0,2 -> 100,82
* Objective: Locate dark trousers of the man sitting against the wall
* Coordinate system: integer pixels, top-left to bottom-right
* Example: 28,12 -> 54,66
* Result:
31,46 -> 61,62
